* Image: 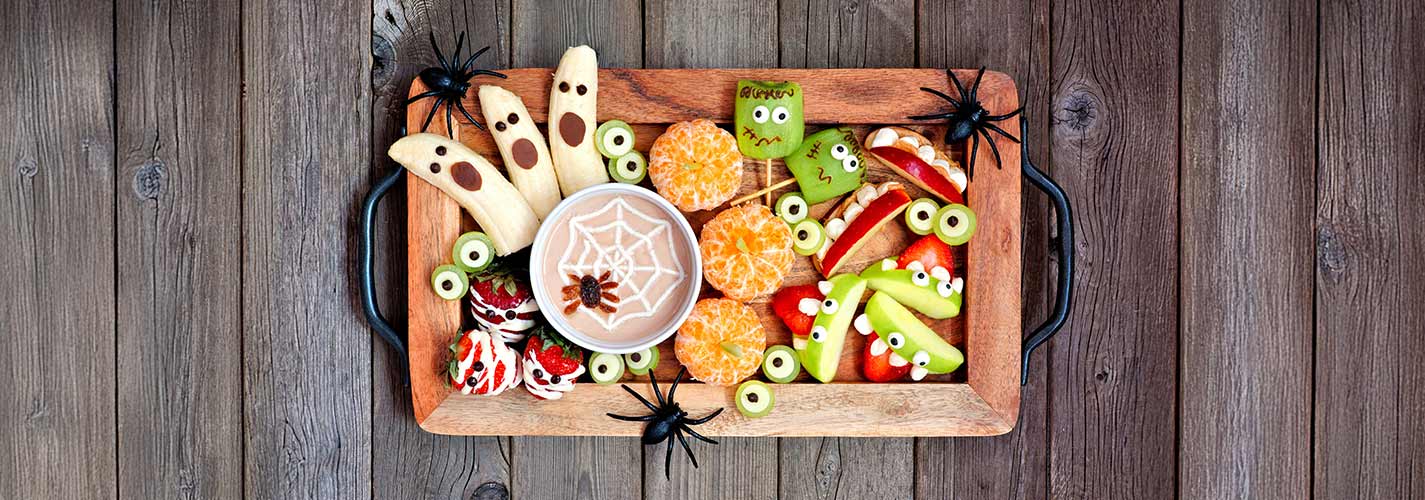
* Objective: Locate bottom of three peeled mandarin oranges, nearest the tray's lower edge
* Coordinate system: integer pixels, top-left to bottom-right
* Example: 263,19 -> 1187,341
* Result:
673,299 -> 767,386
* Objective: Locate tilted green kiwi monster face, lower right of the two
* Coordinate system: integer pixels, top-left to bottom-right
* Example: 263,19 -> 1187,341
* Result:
787,127 -> 866,205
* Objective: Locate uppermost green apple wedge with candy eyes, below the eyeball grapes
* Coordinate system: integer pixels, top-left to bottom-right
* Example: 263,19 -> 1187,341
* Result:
861,259 -> 965,319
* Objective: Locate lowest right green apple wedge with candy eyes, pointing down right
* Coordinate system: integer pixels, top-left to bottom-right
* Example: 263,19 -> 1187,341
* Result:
855,292 -> 965,380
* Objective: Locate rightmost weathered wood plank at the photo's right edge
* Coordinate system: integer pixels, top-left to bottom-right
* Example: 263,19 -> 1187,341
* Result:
1314,1 -> 1425,499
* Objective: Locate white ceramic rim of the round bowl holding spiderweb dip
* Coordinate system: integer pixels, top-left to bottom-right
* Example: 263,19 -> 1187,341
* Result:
530,182 -> 703,355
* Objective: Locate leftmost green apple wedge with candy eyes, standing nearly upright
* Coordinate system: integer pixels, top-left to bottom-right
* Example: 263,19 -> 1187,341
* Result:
801,274 -> 866,383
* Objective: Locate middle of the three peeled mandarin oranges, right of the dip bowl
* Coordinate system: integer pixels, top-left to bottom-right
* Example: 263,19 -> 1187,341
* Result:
698,204 -> 795,302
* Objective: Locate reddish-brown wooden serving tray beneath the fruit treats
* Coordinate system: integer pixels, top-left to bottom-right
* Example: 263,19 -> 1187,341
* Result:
406,68 -> 1022,436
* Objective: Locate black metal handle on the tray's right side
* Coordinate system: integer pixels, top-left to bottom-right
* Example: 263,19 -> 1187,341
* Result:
1019,120 -> 1073,385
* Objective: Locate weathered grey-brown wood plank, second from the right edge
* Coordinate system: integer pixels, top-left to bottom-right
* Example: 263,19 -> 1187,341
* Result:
1178,0 -> 1317,499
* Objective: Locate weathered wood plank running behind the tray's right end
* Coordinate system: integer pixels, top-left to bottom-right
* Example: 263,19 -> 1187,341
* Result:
915,1 -> 1062,499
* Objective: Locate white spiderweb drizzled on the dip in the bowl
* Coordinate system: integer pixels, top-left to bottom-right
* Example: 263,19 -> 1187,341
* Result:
559,198 -> 687,330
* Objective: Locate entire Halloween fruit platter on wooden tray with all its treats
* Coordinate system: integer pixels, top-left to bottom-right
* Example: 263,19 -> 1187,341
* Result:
353,34 -> 1072,460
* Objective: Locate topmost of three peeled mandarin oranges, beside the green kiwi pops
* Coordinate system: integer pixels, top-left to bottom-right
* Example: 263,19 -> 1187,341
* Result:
648,120 -> 742,212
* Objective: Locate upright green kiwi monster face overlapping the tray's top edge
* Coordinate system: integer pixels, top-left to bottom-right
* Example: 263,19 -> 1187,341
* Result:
732,80 -> 805,160
